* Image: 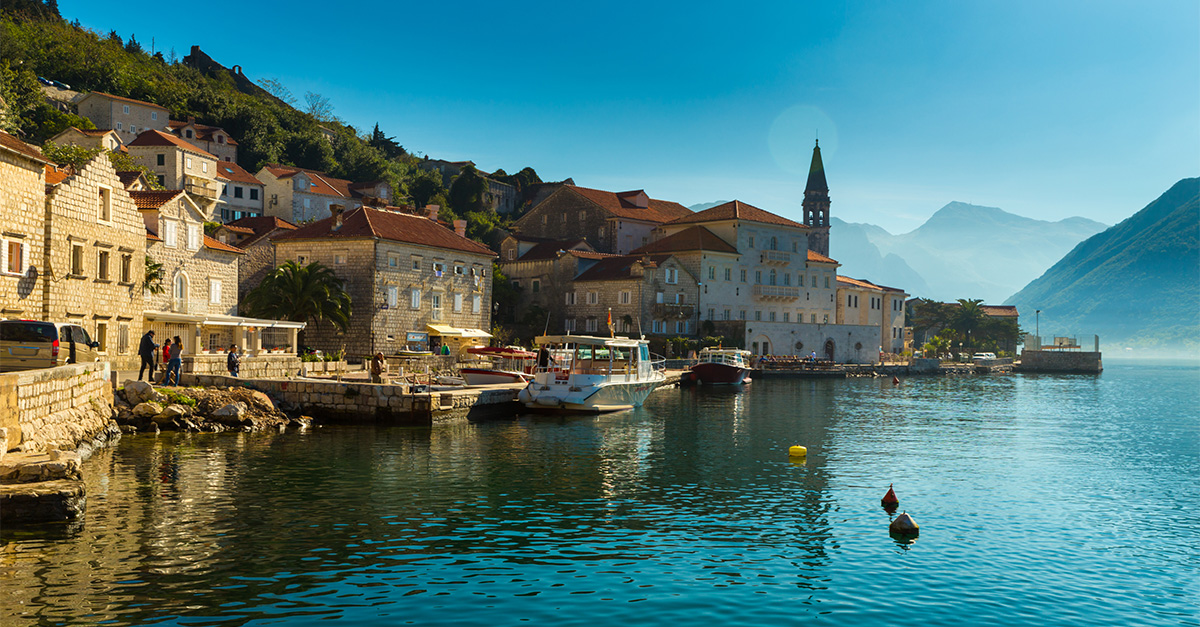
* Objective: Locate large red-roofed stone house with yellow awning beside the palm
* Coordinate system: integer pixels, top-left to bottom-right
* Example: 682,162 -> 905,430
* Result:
271,207 -> 496,360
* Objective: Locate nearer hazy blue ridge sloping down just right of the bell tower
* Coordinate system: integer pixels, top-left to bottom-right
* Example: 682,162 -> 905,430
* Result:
829,217 -> 930,294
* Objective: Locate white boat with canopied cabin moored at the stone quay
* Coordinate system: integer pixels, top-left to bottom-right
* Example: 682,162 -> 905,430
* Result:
517,335 -> 666,413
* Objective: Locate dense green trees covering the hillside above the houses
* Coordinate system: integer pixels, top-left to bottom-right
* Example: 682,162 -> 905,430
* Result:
0,0 -> 540,233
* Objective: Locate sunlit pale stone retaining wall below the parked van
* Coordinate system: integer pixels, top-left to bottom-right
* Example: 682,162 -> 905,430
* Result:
0,362 -> 114,452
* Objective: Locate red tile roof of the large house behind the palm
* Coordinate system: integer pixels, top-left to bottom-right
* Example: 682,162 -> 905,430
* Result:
274,207 -> 496,257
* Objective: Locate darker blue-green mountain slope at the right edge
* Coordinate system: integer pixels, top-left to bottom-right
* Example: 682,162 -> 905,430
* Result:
1008,178 -> 1200,353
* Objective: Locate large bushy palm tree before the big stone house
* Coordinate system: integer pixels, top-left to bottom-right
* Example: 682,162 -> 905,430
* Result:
242,261 -> 350,345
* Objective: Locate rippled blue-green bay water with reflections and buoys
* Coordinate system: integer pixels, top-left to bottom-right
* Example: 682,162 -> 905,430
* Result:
0,364 -> 1200,627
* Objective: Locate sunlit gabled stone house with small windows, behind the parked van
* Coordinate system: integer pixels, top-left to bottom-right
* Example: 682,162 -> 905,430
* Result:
41,154 -> 145,369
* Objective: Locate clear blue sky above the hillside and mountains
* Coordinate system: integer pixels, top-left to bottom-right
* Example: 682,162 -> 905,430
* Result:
59,0 -> 1200,233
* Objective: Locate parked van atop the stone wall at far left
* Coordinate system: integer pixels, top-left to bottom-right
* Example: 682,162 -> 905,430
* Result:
0,320 -> 100,372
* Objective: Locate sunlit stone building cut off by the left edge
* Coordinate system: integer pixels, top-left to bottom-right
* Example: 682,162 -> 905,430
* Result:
0,131 -> 48,318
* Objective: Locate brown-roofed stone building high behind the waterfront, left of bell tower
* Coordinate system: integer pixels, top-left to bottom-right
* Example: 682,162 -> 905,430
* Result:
514,185 -> 691,255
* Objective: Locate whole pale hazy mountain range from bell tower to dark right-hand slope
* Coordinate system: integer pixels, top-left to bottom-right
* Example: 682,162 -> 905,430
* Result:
689,202 -> 1105,304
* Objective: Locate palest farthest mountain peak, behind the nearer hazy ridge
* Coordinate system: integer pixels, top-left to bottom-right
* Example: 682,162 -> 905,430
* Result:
864,202 -> 1105,303
